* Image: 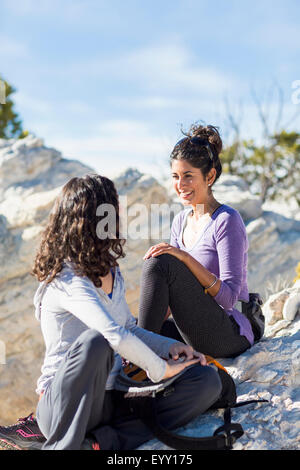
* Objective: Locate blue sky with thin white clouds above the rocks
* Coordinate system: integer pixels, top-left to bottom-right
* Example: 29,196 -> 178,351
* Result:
0,0 -> 300,180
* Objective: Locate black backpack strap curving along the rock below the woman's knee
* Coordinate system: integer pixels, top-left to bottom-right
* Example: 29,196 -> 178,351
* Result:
131,396 -> 244,450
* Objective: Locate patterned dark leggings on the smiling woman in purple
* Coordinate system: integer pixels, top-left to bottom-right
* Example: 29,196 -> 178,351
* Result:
138,254 -> 250,358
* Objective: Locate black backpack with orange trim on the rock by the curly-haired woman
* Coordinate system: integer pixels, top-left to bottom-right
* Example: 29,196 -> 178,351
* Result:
115,356 -> 267,450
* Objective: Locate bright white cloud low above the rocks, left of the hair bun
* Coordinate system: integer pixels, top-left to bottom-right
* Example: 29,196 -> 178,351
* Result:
46,120 -> 174,181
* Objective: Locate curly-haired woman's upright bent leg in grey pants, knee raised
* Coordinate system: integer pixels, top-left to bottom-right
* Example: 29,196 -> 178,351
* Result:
37,330 -> 114,450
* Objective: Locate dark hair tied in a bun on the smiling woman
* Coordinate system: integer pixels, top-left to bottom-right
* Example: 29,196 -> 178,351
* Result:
170,124 -> 223,182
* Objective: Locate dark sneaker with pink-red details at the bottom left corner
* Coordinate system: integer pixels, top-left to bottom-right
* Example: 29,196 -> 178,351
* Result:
0,413 -> 46,450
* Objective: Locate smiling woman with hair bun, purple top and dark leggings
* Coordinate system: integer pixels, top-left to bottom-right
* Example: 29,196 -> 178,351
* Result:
139,125 -> 254,357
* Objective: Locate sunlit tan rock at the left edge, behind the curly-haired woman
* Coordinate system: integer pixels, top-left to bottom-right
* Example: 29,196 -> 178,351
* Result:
0,136 -> 92,424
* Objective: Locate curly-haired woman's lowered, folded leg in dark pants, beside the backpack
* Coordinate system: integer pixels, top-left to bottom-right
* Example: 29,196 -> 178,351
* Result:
92,365 -> 222,450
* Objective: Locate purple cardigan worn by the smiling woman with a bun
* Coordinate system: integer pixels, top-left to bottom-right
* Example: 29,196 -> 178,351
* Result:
170,204 -> 254,344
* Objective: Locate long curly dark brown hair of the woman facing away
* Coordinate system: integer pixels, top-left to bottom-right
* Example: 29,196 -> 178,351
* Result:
32,174 -> 125,287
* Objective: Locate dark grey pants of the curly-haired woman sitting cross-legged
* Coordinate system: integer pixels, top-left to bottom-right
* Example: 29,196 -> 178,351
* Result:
37,330 -> 221,450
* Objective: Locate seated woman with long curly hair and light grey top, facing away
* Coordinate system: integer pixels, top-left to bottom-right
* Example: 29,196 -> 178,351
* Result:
0,175 -> 221,450
